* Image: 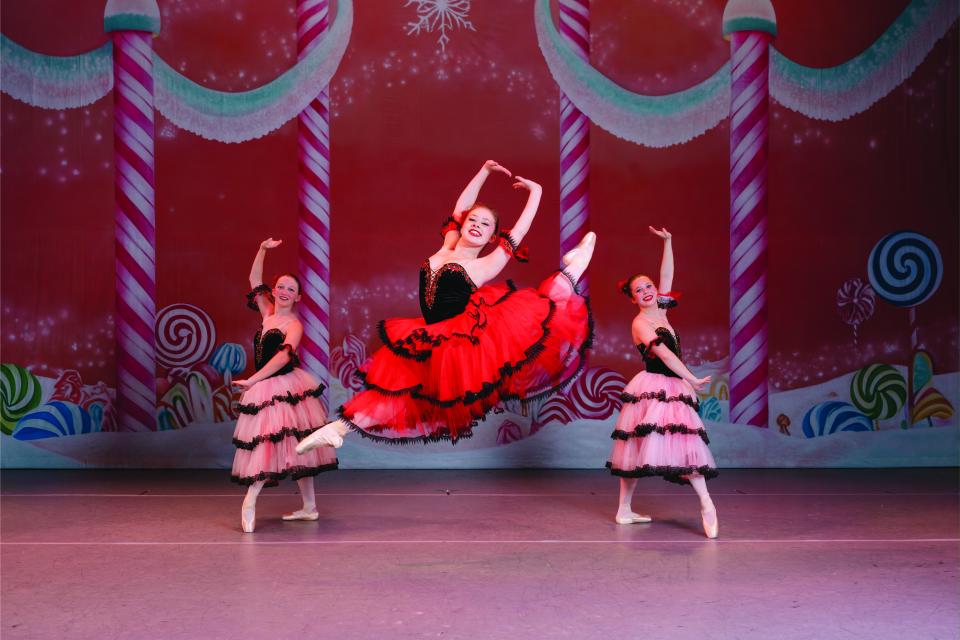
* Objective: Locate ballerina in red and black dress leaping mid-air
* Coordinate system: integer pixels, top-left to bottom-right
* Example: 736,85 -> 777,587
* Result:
297,160 -> 596,452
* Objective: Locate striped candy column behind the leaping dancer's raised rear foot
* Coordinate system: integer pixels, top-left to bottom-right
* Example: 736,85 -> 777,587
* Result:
559,0 -> 590,295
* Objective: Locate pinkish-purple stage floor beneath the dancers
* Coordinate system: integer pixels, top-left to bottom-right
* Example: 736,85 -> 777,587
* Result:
0,469 -> 960,640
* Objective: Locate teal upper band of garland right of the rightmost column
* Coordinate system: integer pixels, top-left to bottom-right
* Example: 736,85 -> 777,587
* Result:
770,0 -> 956,93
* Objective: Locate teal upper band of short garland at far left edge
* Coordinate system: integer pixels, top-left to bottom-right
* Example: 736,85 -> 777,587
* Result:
0,34 -> 113,84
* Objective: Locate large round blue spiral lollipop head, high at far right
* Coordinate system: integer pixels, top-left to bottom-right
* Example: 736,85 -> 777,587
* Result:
867,231 -> 943,307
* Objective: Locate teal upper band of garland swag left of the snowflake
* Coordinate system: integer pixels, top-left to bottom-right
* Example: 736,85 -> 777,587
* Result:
153,0 -> 353,117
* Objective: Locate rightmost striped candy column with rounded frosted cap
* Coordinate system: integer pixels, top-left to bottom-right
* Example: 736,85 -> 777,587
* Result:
723,0 -> 776,427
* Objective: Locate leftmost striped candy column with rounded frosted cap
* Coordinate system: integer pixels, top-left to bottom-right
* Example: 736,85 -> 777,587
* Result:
104,0 -> 160,431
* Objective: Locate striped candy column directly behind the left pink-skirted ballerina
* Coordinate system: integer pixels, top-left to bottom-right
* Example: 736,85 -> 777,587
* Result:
297,0 -> 330,404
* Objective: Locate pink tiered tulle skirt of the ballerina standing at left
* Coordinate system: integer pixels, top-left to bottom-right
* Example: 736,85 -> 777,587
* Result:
231,369 -> 337,486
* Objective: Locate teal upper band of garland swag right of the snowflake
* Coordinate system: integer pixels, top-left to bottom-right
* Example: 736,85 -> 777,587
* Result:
536,0 -> 730,116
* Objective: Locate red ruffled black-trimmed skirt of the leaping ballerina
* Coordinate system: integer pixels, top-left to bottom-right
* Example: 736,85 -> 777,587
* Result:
340,272 -> 593,443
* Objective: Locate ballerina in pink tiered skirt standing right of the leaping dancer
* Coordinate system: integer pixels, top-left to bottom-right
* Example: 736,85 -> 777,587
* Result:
607,227 -> 719,538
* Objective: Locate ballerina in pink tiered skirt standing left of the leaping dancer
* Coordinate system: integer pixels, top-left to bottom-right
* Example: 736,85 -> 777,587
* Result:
231,238 -> 337,533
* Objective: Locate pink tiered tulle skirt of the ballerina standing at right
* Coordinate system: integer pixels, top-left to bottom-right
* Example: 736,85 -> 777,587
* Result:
607,371 -> 717,484
